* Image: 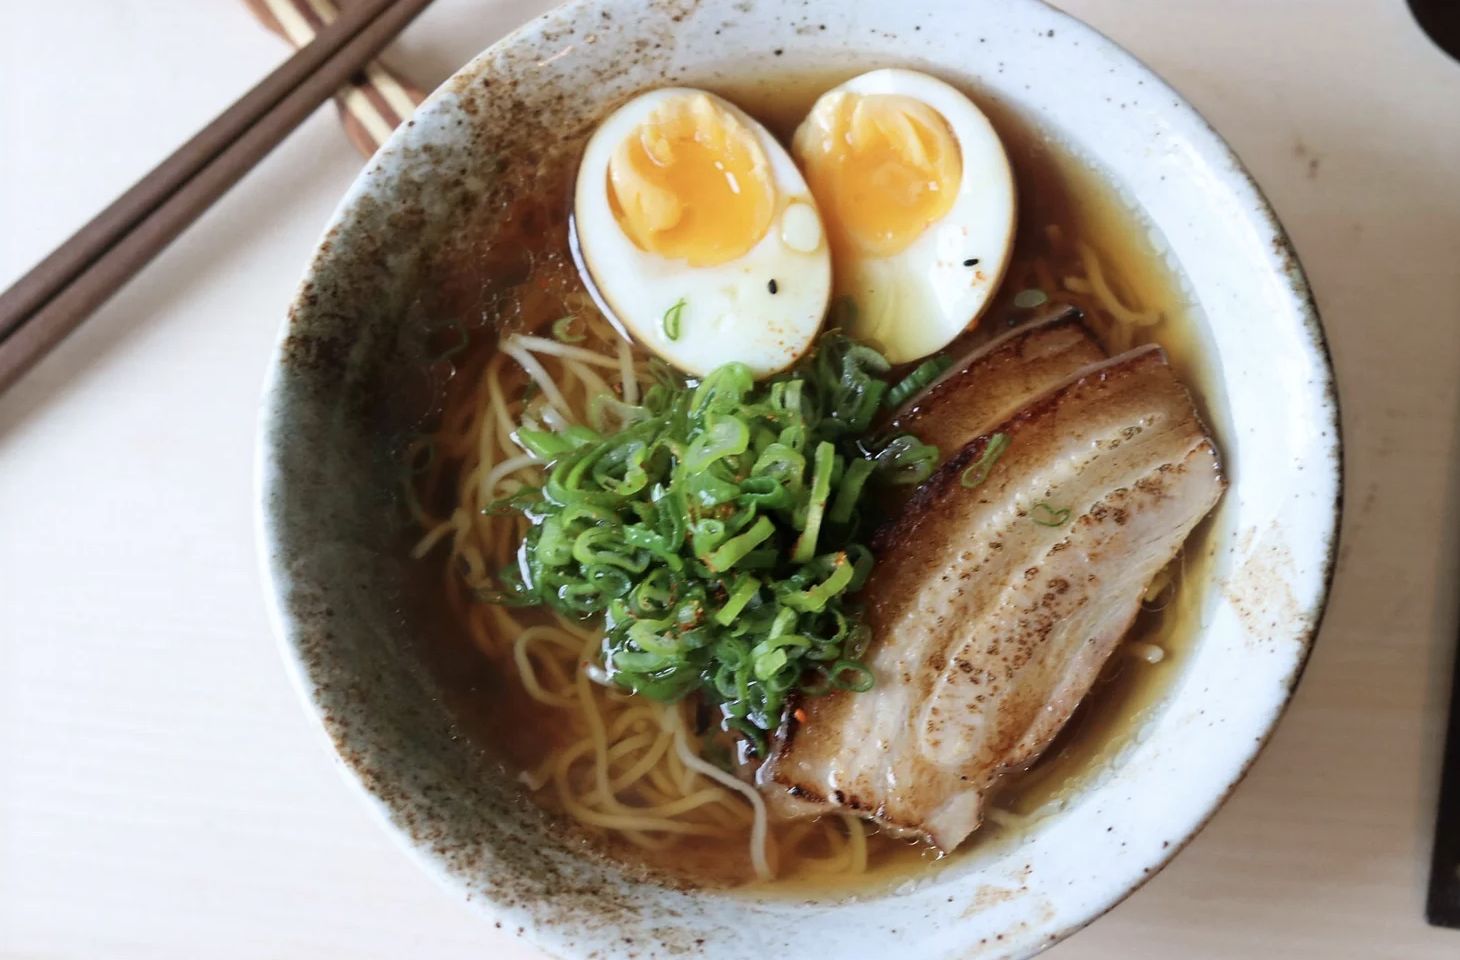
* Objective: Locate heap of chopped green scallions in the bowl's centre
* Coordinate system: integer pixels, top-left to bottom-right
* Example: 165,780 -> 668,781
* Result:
482,332 -> 937,744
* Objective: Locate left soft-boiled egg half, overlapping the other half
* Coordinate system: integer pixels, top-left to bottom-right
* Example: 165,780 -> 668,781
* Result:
574,88 -> 831,376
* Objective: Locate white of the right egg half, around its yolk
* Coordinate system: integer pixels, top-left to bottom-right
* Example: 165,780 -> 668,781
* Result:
811,69 -> 1018,363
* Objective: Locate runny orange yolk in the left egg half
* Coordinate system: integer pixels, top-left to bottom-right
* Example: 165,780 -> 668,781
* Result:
607,93 -> 775,267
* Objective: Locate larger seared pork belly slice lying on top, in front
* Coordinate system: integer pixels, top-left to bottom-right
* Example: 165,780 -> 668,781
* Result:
759,347 -> 1225,851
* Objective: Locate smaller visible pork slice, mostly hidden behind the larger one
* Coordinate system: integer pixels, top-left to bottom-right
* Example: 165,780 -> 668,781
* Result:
888,306 -> 1105,460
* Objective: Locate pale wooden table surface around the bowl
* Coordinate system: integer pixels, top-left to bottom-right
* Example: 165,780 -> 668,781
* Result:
0,0 -> 1460,960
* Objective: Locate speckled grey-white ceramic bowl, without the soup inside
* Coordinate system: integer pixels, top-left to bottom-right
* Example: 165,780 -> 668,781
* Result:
258,0 -> 1340,960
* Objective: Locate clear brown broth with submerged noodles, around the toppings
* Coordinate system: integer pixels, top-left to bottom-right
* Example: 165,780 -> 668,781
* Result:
403,74 -> 1222,891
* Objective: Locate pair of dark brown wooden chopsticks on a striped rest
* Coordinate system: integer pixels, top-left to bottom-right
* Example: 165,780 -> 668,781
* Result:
0,0 -> 431,391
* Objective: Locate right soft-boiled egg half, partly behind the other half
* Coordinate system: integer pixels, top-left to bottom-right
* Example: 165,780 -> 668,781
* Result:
791,70 -> 1016,363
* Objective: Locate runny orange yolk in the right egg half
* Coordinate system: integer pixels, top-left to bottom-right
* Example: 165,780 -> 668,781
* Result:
791,92 -> 964,257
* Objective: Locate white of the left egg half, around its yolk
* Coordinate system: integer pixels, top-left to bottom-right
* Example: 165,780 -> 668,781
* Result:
572,88 -> 831,376
